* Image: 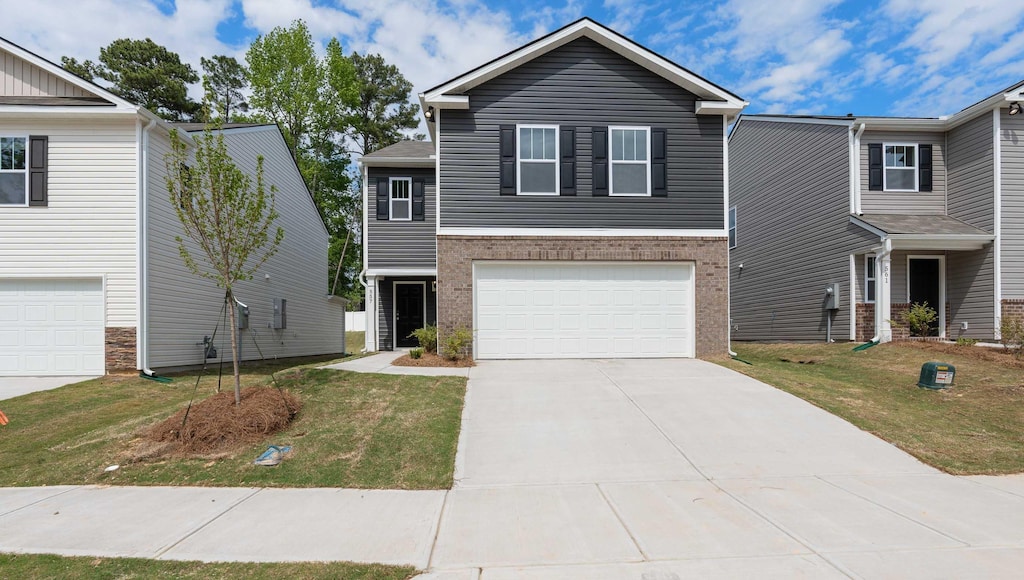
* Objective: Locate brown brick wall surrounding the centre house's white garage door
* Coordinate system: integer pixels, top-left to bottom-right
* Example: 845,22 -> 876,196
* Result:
437,236 -> 729,358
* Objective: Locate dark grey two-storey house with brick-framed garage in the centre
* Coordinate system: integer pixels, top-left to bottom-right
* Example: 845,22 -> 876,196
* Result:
360,18 -> 746,359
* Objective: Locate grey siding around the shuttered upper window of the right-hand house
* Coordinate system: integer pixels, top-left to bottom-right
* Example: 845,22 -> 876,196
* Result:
860,125 -> 946,215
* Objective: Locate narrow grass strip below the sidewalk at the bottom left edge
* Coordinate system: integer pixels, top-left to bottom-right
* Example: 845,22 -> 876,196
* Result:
0,553 -> 415,580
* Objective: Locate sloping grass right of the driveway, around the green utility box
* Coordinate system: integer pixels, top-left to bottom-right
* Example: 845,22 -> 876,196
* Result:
723,342 -> 1024,474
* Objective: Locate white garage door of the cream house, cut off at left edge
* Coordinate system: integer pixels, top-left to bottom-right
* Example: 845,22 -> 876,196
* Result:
0,280 -> 103,376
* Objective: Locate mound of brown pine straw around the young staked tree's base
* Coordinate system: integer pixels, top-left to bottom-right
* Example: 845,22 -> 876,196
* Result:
145,386 -> 302,459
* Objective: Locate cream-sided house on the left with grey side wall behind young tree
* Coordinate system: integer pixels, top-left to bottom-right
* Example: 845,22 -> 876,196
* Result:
0,39 -> 344,376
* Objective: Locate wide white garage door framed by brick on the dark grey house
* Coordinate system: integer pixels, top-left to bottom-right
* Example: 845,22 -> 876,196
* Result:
473,262 -> 694,359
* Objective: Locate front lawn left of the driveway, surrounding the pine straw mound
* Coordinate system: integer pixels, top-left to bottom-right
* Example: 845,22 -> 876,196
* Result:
0,356 -> 466,489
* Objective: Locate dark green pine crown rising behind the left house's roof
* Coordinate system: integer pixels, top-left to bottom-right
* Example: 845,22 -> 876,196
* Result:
60,38 -> 201,121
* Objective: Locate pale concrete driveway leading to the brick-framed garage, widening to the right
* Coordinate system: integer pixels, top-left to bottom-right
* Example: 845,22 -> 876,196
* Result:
430,360 -> 1024,580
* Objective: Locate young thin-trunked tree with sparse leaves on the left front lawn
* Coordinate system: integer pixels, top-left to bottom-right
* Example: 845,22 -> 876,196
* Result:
164,127 -> 285,405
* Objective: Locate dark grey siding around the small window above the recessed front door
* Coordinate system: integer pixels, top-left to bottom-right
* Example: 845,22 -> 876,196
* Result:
367,167 -> 437,268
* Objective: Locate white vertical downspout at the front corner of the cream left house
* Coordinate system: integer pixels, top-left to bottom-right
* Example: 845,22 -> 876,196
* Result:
135,118 -> 157,376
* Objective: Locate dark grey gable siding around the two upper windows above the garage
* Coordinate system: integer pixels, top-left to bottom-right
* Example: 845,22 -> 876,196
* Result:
438,39 -> 724,230
